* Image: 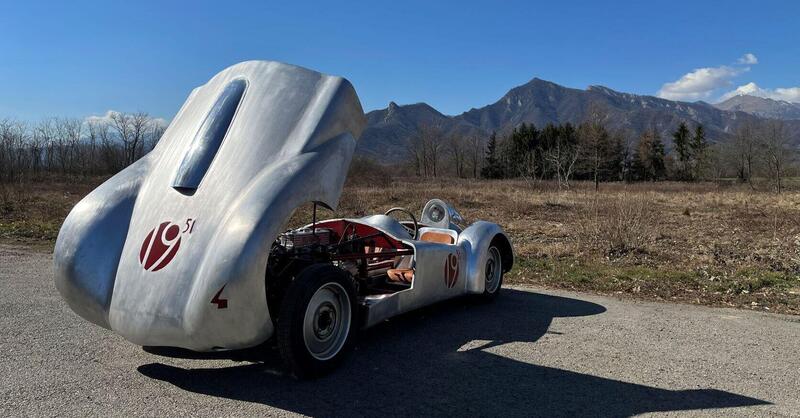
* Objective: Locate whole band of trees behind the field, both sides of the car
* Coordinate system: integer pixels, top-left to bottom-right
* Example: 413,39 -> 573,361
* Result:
0,110 -> 797,192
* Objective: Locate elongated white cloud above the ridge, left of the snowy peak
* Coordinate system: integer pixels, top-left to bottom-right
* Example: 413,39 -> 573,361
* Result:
656,65 -> 755,101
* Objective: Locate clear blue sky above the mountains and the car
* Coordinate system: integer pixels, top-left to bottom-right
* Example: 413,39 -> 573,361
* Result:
0,0 -> 800,120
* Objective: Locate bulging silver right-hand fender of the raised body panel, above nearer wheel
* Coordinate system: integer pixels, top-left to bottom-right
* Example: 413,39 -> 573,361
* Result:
184,133 -> 356,349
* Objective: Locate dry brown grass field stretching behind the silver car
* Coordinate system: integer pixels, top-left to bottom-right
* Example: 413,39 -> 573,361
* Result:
0,179 -> 800,314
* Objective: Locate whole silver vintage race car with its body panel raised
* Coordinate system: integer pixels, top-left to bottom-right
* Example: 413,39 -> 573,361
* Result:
54,61 -> 514,377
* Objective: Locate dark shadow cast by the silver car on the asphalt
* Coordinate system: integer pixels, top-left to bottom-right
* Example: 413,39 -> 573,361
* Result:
138,289 -> 768,416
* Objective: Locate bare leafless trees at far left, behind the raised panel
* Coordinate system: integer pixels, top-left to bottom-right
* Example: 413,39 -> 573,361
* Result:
0,112 -> 165,183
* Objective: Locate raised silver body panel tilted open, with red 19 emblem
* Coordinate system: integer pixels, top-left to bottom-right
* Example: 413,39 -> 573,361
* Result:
56,61 -> 364,350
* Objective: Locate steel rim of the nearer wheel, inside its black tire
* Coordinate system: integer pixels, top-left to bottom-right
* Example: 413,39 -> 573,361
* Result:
303,282 -> 351,360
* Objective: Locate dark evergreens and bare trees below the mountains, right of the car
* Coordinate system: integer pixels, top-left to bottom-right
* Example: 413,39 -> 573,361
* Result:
408,111 -> 797,192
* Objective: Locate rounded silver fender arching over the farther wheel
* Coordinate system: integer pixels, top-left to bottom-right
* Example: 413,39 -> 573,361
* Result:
458,221 -> 514,294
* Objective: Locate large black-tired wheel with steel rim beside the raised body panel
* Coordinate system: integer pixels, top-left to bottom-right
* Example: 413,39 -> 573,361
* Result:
277,264 -> 359,379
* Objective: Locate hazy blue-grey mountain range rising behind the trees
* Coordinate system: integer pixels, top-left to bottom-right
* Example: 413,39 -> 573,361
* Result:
357,78 -> 800,163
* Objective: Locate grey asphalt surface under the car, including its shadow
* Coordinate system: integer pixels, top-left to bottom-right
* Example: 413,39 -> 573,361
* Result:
0,245 -> 800,417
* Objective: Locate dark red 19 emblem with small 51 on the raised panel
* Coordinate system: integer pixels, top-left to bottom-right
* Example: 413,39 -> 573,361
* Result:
139,218 -> 195,271
